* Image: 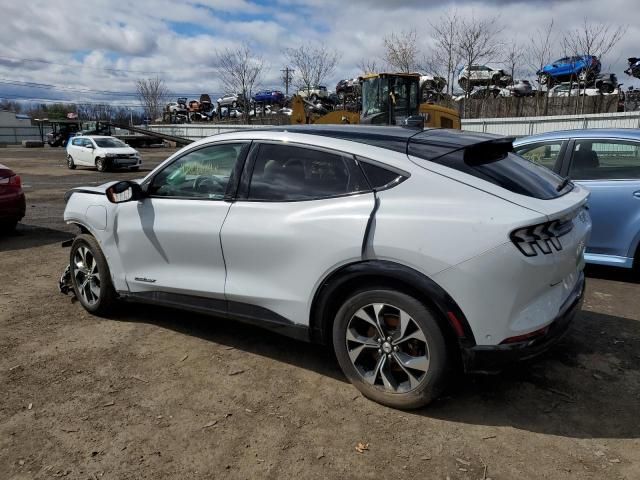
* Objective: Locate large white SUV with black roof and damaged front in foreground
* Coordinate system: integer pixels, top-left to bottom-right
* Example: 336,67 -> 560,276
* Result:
61,125 -> 591,408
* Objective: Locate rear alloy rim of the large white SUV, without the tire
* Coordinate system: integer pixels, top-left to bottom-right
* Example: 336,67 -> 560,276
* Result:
346,303 -> 430,393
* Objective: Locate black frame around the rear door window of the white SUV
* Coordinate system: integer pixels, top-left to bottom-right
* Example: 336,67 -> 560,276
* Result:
236,140 -> 373,203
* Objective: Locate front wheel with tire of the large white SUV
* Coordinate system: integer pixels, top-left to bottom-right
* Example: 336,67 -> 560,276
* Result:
69,234 -> 116,316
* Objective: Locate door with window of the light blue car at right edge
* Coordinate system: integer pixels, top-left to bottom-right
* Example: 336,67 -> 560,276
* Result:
568,139 -> 640,266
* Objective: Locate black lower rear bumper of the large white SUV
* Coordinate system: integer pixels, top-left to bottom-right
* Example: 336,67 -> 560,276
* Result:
462,273 -> 585,373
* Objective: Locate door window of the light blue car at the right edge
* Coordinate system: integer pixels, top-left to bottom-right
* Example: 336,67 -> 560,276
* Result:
569,139 -> 640,180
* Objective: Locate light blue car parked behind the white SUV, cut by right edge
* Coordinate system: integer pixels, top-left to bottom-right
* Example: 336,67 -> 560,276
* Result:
514,128 -> 640,268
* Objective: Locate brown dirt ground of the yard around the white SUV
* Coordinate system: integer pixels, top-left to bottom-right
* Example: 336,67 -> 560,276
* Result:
0,147 -> 640,480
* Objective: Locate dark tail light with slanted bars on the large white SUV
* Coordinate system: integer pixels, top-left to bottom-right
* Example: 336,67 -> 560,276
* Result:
511,218 -> 573,257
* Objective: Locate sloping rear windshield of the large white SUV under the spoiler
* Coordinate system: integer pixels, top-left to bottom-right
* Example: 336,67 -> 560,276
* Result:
416,150 -> 573,200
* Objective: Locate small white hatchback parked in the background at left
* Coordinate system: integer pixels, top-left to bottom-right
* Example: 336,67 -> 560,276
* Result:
67,135 -> 142,172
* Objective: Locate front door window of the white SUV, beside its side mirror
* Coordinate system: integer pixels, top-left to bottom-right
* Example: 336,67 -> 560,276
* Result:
149,143 -> 247,200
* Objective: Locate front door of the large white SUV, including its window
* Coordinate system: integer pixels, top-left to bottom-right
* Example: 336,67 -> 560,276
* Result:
114,142 -> 250,301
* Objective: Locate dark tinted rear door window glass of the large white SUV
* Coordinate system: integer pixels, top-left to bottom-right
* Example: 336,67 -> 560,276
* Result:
248,144 -> 368,201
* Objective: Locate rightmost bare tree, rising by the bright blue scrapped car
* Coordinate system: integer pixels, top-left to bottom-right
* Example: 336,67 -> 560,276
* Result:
562,18 -> 628,113
